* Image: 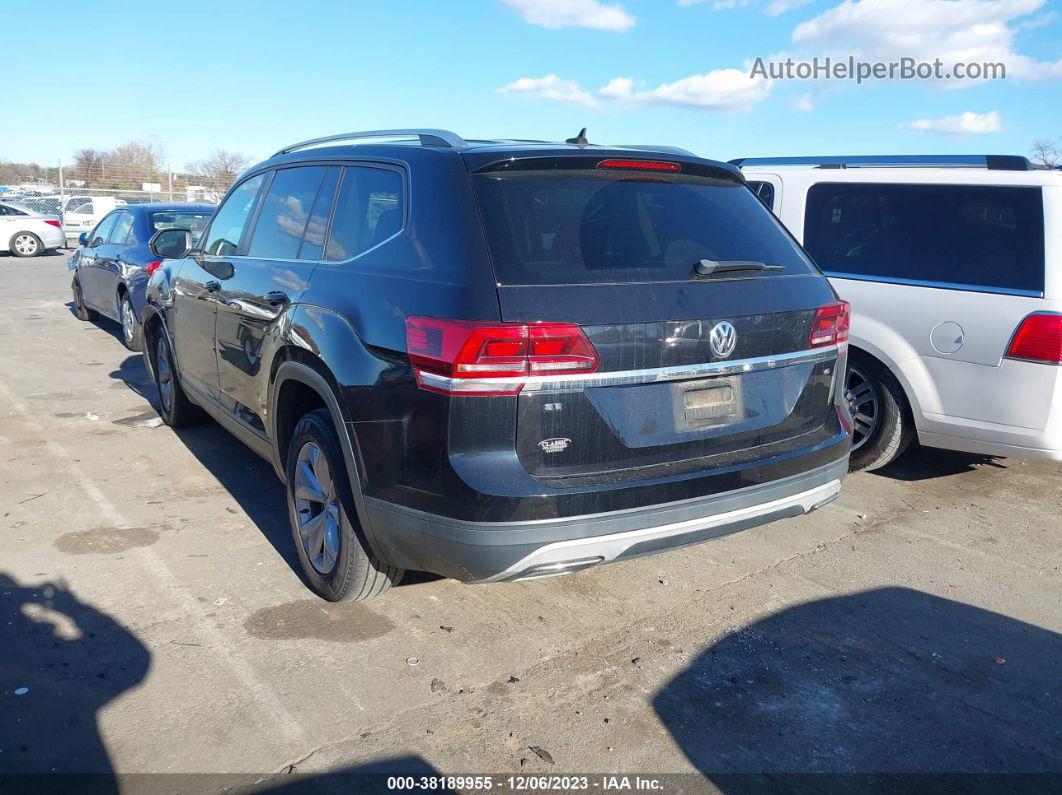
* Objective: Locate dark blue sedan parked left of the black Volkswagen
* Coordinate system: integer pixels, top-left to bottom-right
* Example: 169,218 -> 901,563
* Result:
70,204 -> 213,350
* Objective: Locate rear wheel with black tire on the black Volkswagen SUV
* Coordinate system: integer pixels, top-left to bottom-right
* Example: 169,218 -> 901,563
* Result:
285,409 -> 405,602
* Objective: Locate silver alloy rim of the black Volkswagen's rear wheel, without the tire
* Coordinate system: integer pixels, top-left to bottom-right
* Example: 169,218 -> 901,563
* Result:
293,442 -> 340,574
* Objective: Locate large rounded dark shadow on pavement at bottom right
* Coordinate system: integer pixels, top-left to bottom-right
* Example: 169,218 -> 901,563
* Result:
653,588 -> 1062,792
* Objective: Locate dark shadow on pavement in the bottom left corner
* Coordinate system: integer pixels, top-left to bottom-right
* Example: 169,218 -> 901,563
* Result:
0,573 -> 151,792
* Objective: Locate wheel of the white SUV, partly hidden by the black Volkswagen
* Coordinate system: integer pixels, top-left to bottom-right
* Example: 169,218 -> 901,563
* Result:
844,351 -> 914,472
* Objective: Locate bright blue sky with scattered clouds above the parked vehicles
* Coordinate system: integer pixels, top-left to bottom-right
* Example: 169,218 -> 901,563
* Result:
0,0 -> 1062,170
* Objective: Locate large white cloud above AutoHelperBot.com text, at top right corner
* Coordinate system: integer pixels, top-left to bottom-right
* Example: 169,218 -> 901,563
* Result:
792,0 -> 1062,80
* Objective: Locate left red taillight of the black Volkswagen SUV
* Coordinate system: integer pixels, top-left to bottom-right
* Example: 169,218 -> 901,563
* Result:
406,316 -> 598,396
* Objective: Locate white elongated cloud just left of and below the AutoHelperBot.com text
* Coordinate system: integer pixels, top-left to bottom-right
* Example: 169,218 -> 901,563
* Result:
598,69 -> 771,110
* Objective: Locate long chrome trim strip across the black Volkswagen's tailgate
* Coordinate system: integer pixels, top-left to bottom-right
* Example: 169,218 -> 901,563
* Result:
421,345 -> 838,394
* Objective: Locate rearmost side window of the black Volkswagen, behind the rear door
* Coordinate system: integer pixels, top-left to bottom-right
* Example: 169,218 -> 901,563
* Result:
325,166 -> 406,261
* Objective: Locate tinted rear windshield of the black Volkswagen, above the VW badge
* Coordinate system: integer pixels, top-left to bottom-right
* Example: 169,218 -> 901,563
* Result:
473,170 -> 815,284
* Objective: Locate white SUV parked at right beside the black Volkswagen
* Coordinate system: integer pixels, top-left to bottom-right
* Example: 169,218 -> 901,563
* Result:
732,155 -> 1062,469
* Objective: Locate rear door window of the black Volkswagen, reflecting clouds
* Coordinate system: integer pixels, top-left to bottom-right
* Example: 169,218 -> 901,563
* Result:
247,166 -> 328,259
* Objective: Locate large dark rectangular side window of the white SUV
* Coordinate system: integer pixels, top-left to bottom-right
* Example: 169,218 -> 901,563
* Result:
804,183 -> 1044,293
